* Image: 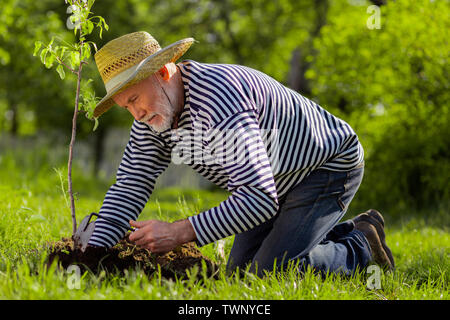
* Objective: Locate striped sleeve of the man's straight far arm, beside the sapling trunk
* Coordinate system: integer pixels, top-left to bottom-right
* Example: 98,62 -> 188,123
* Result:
89,121 -> 171,247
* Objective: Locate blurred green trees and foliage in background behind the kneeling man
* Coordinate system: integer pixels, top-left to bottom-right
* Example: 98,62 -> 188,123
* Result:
0,0 -> 450,212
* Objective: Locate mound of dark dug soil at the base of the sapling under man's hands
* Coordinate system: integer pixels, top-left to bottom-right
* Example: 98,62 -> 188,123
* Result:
47,237 -> 216,279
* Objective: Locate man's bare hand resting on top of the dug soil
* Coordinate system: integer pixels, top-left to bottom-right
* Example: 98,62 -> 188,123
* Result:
129,219 -> 196,253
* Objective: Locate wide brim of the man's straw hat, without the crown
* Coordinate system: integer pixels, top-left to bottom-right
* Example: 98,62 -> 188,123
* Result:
94,38 -> 195,118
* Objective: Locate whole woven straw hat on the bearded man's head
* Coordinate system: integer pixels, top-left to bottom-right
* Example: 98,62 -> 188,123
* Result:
94,31 -> 195,118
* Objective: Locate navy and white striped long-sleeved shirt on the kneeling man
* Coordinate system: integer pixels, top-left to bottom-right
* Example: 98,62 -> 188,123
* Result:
89,60 -> 364,246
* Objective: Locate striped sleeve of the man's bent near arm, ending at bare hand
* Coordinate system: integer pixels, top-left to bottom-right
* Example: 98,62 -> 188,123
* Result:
189,110 -> 278,246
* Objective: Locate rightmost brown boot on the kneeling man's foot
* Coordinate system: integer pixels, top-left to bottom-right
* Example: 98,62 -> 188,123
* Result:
353,209 -> 395,270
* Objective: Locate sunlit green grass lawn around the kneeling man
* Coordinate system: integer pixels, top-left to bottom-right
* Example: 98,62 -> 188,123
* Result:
0,143 -> 450,299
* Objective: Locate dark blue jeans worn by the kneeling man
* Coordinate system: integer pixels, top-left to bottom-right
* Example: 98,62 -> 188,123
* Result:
227,162 -> 371,276
